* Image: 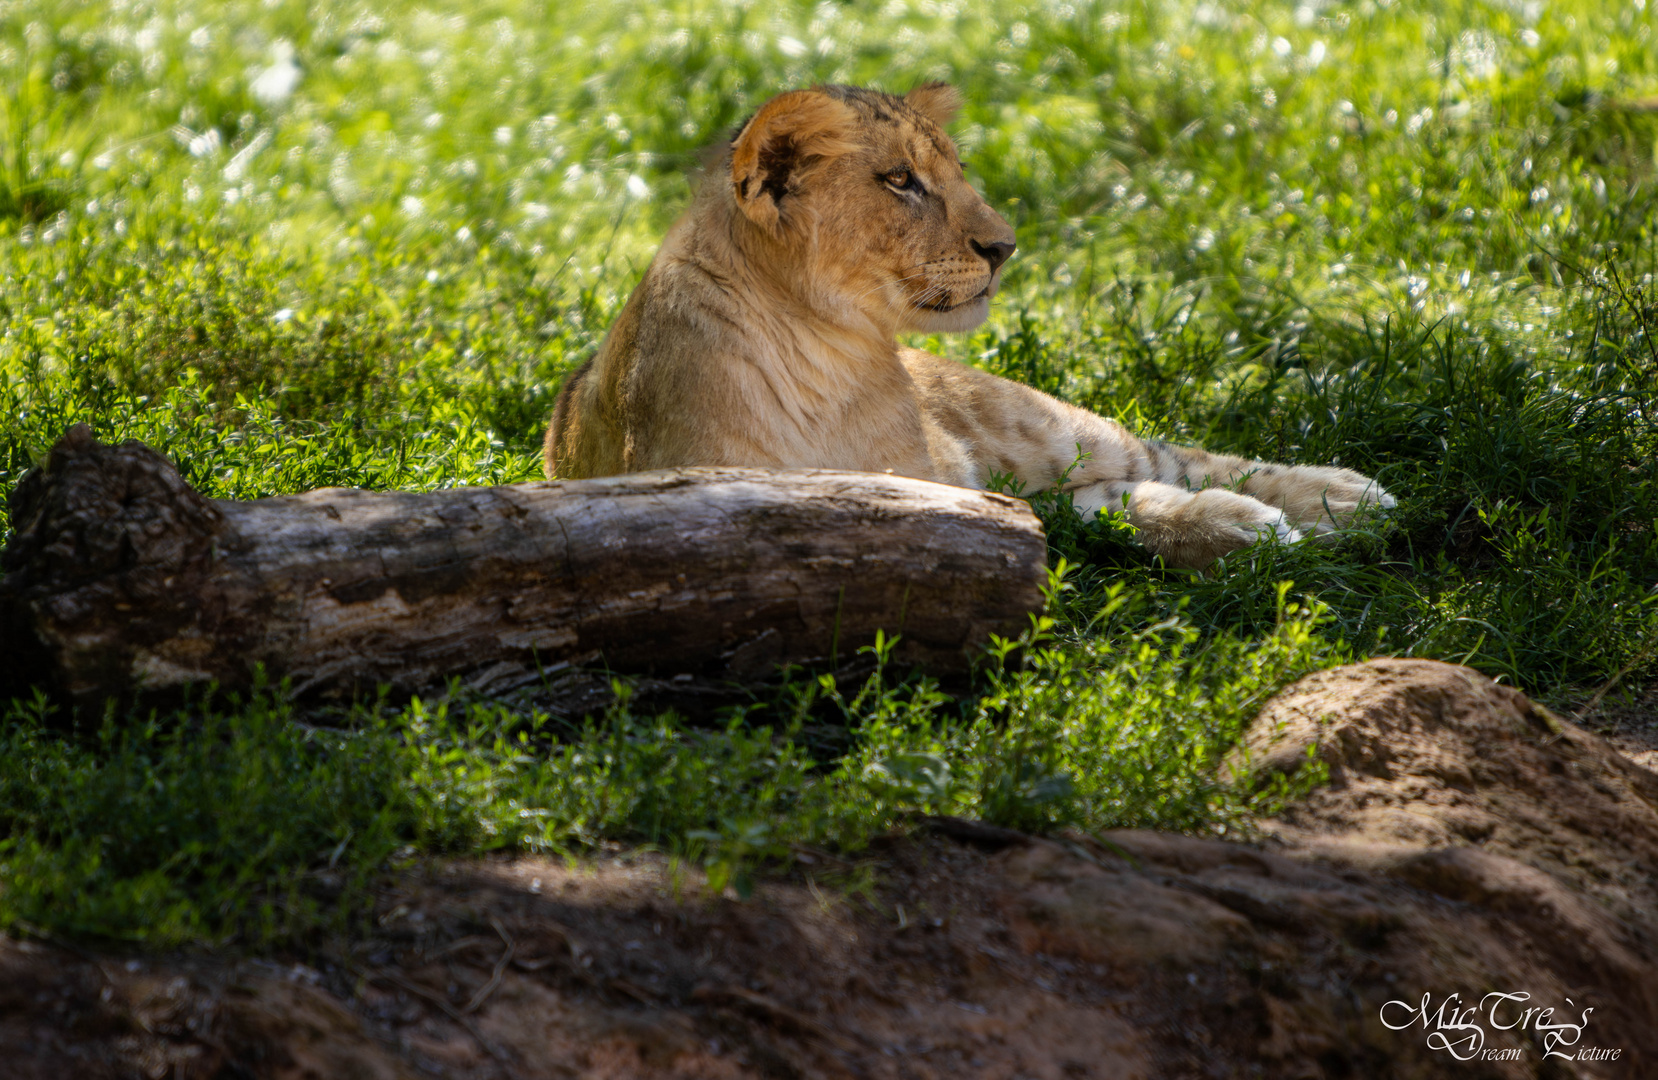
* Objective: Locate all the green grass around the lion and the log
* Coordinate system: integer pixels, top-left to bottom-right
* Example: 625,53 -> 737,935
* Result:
0,0 -> 1658,942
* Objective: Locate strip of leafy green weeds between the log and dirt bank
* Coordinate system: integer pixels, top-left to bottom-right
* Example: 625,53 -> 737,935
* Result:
0,592 -> 1343,944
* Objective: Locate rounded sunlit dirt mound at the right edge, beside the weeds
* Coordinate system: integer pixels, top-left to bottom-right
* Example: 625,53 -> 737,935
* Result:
1235,660 -> 1658,919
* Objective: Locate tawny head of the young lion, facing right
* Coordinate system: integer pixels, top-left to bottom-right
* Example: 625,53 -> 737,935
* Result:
730,83 -> 1015,332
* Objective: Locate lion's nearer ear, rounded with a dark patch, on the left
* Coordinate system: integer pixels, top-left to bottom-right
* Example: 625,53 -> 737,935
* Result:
731,90 -> 857,234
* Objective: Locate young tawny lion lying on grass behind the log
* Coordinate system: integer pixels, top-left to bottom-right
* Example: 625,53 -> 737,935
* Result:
547,83 -> 1393,567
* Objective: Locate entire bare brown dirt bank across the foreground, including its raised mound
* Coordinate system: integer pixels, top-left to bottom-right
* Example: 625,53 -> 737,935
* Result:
0,660 -> 1658,1080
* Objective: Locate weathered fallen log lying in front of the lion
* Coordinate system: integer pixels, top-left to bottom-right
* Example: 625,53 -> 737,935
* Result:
0,425 -> 1045,715
